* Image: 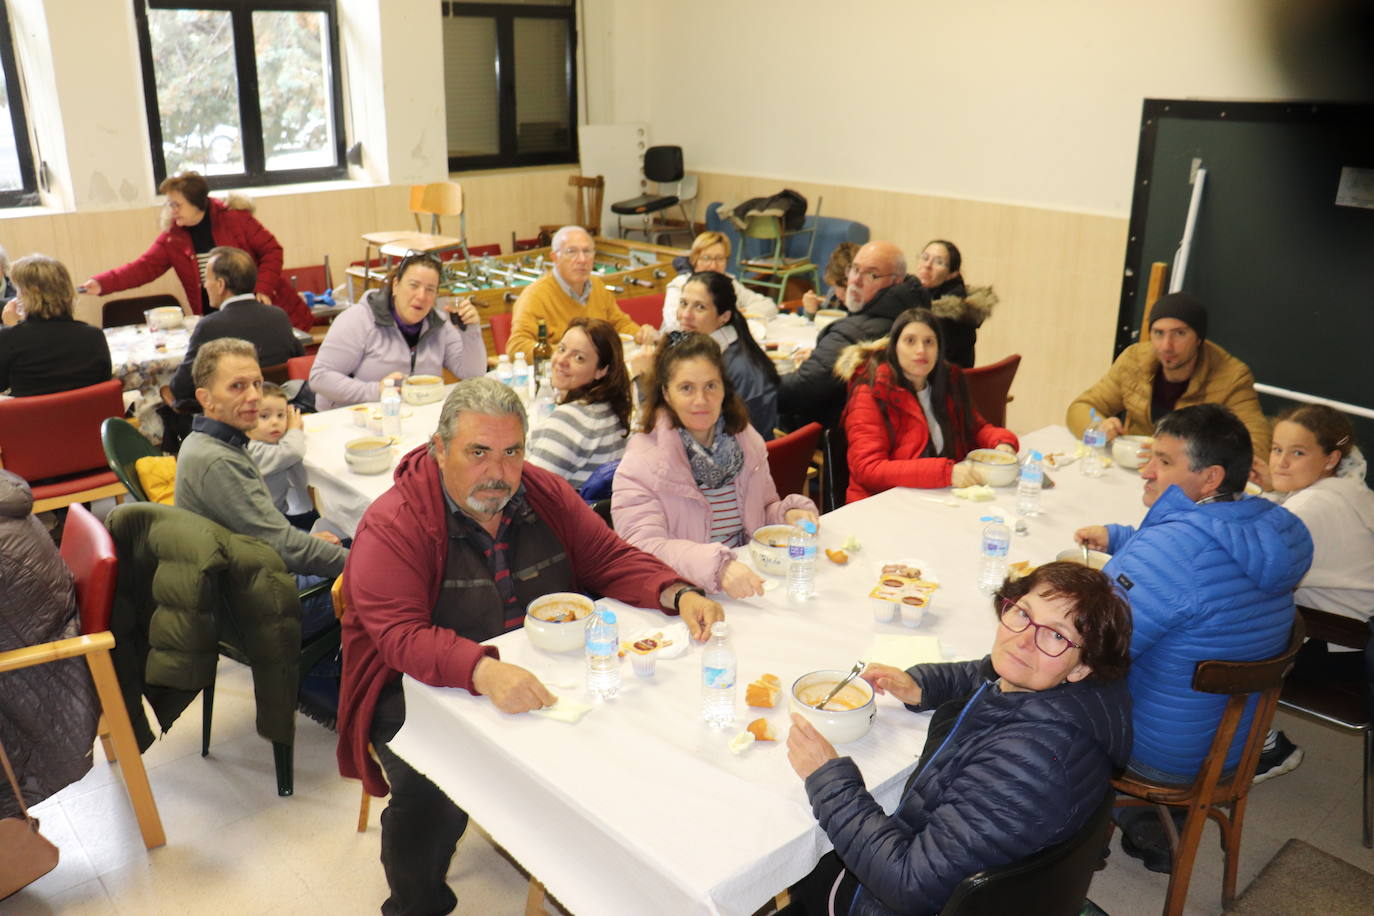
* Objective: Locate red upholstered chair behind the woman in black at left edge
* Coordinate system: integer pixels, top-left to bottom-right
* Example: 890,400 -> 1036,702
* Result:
0,379 -> 128,512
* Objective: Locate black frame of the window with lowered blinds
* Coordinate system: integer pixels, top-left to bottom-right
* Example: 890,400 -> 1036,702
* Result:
440,0 -> 578,172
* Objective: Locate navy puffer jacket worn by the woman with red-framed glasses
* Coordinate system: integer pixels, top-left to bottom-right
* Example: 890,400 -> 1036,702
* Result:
807,659 -> 1131,916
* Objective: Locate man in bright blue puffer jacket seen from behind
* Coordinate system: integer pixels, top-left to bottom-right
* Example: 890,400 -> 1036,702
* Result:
1077,404 -> 1312,871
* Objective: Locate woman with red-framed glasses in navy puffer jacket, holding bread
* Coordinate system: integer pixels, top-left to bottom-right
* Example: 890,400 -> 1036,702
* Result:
787,563 -> 1131,916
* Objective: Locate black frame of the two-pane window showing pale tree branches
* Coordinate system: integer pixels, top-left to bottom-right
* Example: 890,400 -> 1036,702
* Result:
133,0 -> 348,190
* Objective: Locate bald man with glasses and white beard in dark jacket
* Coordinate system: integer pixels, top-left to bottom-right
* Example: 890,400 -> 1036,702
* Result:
778,242 -> 930,428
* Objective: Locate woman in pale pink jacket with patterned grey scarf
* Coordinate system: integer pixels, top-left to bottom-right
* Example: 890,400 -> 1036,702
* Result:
611,332 -> 816,597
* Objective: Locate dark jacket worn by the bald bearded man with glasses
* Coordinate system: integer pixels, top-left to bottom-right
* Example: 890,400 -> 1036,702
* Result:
778,276 -> 930,427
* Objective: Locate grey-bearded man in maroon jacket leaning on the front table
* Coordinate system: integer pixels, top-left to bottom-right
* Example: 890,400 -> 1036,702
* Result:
338,378 -> 723,913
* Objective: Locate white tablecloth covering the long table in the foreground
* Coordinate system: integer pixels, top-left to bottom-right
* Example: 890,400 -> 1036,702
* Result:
381,427 -> 1143,916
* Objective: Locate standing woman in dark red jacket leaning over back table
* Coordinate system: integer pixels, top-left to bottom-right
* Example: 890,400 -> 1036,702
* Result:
81,172 -> 315,331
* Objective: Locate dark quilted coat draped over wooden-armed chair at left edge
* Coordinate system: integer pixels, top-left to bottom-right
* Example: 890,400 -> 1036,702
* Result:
0,471 -> 100,817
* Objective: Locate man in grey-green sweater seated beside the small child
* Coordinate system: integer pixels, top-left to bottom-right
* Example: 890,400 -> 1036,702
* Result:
176,338 -> 348,579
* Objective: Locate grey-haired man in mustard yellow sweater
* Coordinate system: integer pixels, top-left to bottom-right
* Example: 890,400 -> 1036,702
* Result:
506,225 -> 658,358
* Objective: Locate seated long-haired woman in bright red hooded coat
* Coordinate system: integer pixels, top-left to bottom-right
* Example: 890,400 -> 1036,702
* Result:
835,309 -> 1018,503
